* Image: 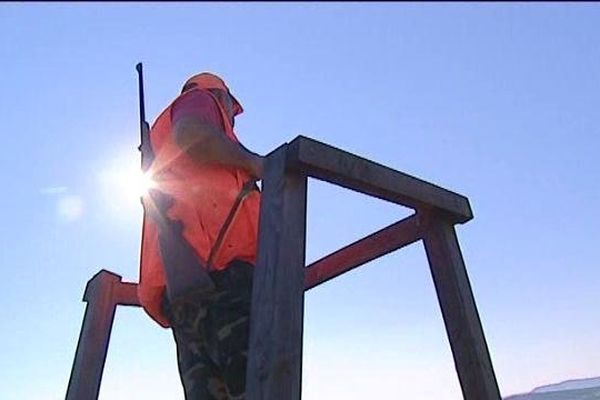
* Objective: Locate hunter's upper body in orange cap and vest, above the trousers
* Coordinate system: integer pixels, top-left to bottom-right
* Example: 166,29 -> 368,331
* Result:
138,73 -> 262,327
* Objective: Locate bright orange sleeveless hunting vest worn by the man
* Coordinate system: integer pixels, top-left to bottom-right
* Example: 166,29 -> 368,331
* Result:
138,89 -> 260,327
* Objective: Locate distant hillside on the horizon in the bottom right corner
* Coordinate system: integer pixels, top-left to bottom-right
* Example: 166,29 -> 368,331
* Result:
505,377 -> 600,400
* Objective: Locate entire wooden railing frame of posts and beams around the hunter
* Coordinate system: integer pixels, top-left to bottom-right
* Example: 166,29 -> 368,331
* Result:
67,136 -> 500,400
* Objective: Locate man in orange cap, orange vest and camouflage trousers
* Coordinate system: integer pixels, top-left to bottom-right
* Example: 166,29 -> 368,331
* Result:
138,73 -> 263,400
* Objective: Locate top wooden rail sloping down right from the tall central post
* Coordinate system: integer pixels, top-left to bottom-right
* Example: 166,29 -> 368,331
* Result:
289,136 -> 473,223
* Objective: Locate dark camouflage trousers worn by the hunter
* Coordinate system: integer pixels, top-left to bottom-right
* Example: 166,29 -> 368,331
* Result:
164,261 -> 254,400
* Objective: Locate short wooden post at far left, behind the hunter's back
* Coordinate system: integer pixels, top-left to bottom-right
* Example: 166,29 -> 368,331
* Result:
66,270 -> 121,400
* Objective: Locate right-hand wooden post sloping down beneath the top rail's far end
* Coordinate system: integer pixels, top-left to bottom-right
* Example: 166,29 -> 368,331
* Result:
424,214 -> 500,400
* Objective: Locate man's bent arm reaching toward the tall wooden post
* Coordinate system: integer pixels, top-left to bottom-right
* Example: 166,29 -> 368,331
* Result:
173,100 -> 263,178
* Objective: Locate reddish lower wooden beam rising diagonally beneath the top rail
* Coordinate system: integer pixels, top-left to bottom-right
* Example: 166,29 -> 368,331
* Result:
304,214 -> 421,290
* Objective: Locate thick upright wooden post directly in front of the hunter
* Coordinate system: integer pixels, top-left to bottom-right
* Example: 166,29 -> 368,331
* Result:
246,145 -> 307,400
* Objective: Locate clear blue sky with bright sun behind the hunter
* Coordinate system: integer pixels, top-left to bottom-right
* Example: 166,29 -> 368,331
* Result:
0,3 -> 600,400
